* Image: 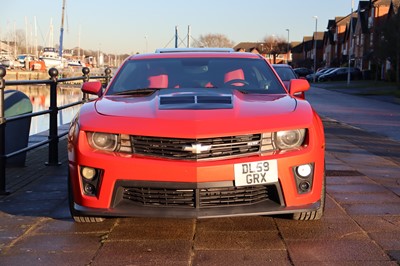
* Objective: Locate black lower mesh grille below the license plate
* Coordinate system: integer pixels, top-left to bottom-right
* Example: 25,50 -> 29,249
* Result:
123,185 -> 279,208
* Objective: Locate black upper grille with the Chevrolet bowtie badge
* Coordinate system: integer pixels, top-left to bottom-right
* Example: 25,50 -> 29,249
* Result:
131,134 -> 274,161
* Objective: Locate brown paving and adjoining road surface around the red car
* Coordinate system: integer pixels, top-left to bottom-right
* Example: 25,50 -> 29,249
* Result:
0,85 -> 400,266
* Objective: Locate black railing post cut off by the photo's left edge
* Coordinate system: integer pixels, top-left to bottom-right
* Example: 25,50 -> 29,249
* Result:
0,66 -> 9,195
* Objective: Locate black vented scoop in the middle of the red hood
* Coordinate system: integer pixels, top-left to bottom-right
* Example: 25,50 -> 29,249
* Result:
160,94 -> 233,110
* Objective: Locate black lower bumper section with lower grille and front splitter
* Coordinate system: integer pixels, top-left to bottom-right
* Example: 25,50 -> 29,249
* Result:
73,181 -> 321,218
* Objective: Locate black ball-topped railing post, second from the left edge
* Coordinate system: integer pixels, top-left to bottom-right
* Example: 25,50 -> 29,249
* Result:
46,68 -> 61,166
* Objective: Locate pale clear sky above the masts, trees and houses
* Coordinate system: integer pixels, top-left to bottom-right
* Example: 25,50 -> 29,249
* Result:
0,0 -> 358,54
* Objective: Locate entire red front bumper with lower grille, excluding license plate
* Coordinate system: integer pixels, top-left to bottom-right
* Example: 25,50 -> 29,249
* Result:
69,128 -> 325,218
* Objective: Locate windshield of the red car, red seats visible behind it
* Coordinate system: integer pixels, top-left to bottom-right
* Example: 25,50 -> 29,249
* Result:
106,58 -> 286,95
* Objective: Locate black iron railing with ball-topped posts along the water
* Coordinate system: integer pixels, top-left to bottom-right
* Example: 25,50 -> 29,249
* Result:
0,67 -> 111,195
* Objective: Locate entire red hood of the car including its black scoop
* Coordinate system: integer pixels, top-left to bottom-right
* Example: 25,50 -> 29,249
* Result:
79,89 -> 313,138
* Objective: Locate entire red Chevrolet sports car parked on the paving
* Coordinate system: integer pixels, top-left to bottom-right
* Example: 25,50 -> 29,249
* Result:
68,48 -> 325,222
